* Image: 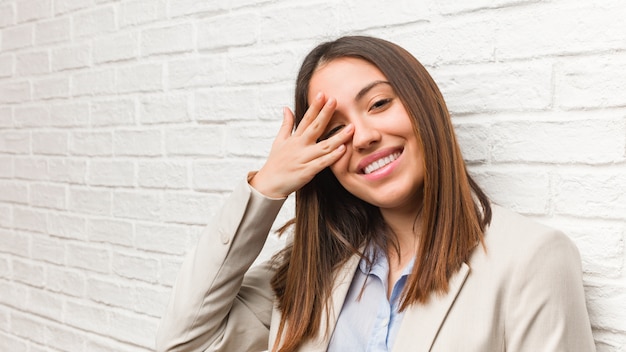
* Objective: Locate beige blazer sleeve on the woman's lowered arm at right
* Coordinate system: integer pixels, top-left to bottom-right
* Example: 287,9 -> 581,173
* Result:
505,230 -> 595,352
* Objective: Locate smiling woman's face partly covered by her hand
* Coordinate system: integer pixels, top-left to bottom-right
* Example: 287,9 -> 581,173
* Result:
308,58 -> 424,213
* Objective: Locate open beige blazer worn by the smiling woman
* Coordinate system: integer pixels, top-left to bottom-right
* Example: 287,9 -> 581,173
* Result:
156,182 -> 595,352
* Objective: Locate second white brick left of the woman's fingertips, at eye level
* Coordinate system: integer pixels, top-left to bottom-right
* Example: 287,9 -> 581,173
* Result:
195,87 -> 255,122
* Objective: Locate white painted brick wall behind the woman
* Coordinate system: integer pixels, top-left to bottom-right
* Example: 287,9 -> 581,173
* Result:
0,0 -> 626,352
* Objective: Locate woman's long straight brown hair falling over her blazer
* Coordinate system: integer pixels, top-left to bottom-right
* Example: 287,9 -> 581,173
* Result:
271,36 -> 491,352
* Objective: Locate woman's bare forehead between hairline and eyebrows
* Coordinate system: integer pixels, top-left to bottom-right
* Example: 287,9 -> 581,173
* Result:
307,57 -> 387,101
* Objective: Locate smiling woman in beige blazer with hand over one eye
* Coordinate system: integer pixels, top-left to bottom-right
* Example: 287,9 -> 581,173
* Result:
157,37 -> 594,352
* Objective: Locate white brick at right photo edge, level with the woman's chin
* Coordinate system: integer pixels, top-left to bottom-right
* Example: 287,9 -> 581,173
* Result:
554,168 -> 626,220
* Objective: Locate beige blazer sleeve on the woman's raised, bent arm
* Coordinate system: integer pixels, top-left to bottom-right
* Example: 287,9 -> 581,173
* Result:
156,182 -> 284,351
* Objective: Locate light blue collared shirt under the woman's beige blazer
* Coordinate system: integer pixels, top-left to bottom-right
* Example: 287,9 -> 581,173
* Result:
328,251 -> 413,352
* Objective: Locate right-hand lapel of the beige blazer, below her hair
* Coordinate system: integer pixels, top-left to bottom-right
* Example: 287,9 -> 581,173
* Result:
393,263 -> 470,352
